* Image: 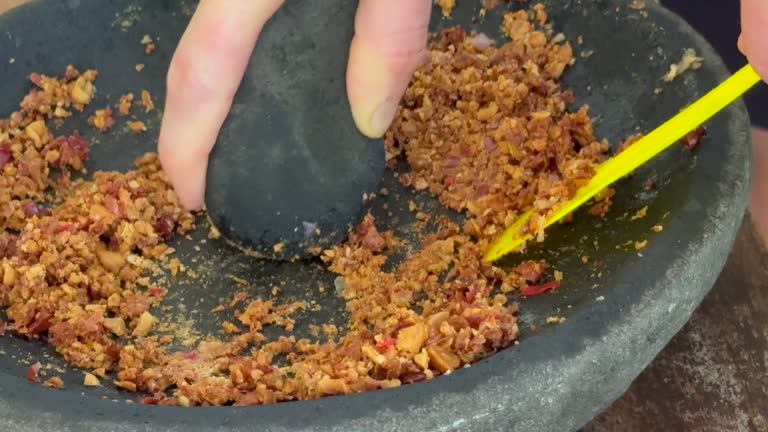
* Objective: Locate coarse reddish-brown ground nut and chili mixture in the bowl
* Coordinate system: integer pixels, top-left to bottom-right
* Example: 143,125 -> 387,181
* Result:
0,5 -> 608,406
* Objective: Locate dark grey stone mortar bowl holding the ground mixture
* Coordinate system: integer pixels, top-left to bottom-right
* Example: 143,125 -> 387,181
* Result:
0,0 -> 751,432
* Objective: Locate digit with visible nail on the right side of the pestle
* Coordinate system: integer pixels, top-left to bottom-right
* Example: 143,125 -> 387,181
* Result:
347,0 -> 432,137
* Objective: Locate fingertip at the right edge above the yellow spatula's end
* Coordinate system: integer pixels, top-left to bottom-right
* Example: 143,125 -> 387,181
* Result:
739,0 -> 768,80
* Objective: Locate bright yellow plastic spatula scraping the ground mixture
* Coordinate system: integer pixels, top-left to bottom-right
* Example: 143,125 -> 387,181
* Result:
485,65 -> 760,262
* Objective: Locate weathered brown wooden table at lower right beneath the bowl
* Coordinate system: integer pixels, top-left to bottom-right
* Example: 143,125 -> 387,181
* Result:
584,217 -> 768,432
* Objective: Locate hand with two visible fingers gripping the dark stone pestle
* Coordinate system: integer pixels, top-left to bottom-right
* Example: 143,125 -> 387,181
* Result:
158,0 -> 432,210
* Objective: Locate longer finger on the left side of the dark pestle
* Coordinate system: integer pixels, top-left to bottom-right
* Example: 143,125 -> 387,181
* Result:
158,0 -> 283,209
